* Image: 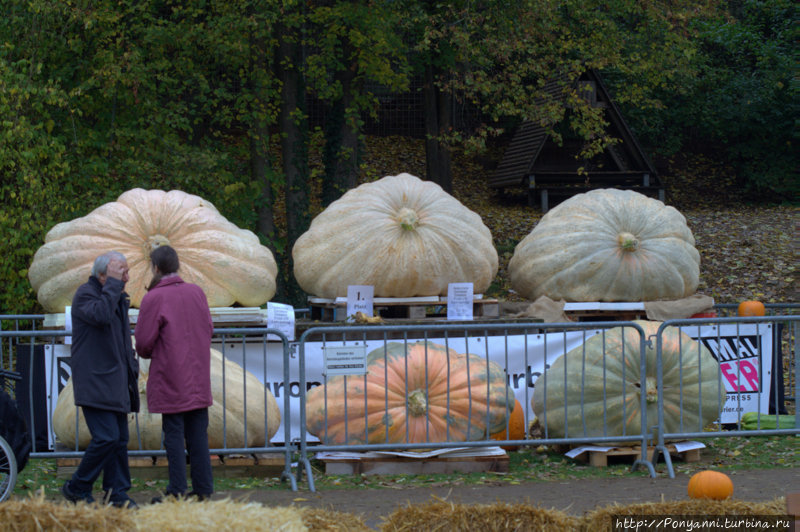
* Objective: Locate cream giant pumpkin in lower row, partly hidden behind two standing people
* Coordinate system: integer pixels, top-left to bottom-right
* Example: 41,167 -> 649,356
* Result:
53,349 -> 281,450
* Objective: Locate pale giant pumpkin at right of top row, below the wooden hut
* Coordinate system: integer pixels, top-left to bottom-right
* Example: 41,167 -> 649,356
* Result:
508,189 -> 700,301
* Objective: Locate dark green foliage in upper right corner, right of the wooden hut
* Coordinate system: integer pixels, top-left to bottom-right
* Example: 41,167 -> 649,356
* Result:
611,0 -> 800,199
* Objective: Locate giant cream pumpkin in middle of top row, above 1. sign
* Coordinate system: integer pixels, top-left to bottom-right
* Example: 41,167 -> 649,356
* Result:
292,174 -> 497,298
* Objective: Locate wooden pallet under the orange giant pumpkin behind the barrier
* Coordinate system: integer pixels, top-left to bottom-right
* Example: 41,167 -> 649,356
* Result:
322,453 -> 508,475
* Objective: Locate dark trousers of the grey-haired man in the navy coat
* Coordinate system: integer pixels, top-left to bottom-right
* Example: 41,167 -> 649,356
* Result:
70,406 -> 131,501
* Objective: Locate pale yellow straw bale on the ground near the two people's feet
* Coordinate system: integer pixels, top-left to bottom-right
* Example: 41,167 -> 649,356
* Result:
135,498 -> 308,532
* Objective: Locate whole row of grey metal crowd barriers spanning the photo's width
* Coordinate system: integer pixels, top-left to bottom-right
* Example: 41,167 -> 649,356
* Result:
0,312 -> 800,491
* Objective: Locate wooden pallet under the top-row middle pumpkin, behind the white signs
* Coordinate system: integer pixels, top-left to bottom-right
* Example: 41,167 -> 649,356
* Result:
309,297 -> 500,321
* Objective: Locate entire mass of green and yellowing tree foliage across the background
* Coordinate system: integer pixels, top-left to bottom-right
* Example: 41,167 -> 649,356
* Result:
0,0 -> 800,313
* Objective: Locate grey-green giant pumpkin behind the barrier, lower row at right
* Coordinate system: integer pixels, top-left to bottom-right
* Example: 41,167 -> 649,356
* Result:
531,321 -> 725,438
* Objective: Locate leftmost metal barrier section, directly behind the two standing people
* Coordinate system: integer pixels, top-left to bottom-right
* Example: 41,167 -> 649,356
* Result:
0,327 -> 297,490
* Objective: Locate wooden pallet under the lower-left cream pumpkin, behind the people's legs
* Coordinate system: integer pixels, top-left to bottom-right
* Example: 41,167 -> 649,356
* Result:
56,453 -> 284,480
